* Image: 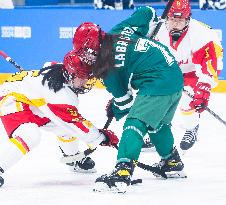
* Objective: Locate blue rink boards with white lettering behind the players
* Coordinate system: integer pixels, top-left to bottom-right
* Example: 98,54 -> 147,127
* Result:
0,7 -> 226,92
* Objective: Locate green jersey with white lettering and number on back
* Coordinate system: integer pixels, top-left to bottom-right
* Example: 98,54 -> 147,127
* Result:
104,8 -> 183,98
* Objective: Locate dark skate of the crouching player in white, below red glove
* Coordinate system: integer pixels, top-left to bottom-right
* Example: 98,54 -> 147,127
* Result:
67,157 -> 96,173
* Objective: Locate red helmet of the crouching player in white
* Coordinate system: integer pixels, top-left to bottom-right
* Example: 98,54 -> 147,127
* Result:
64,50 -> 92,81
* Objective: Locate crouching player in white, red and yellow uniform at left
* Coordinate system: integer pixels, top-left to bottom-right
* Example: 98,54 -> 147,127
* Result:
0,50 -> 118,186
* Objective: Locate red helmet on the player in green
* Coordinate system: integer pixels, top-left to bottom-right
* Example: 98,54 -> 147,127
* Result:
73,22 -> 104,65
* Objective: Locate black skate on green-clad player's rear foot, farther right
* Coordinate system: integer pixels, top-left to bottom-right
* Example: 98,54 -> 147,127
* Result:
153,148 -> 187,178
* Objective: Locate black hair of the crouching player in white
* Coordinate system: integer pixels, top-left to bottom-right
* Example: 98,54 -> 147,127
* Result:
39,64 -> 66,93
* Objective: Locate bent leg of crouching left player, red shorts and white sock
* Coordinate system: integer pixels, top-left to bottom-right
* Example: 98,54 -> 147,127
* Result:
0,93 -> 49,187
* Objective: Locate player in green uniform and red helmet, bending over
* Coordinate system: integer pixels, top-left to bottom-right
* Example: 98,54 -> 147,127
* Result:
73,5 -> 184,193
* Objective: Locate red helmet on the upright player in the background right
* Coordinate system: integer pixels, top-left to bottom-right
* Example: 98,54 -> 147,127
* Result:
167,0 -> 191,19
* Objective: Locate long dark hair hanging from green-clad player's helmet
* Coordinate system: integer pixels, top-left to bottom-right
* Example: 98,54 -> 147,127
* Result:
93,33 -> 115,79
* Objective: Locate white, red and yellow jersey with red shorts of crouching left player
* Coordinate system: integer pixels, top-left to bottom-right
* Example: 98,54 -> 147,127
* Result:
0,71 -> 102,147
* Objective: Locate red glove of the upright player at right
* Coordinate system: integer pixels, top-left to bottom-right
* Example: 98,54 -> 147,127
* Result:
190,82 -> 211,113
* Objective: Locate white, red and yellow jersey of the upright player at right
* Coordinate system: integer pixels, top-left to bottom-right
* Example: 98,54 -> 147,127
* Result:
156,19 -> 223,87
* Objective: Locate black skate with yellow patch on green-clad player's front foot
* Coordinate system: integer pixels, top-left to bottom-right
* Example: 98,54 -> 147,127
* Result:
93,162 -> 134,193
